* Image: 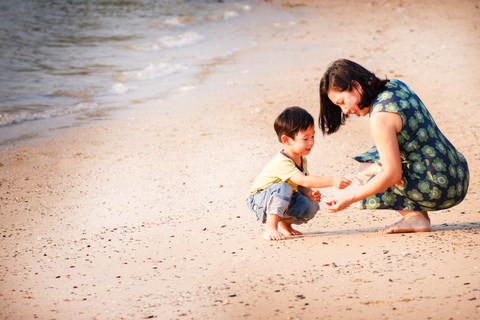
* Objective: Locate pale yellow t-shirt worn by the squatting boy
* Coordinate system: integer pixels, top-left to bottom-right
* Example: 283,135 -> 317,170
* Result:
247,151 -> 308,198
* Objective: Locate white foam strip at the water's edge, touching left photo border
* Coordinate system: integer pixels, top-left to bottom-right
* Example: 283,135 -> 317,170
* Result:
0,102 -> 98,127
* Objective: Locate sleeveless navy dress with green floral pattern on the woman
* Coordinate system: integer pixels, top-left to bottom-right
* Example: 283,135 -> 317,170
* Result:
353,79 -> 469,211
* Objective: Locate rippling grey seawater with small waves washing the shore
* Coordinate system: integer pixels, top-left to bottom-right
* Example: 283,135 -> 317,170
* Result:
0,0 -> 257,126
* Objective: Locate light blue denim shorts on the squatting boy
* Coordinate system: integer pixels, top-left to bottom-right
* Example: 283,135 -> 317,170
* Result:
247,183 -> 320,224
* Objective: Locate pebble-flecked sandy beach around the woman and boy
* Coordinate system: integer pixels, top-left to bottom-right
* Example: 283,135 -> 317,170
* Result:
0,0 -> 480,320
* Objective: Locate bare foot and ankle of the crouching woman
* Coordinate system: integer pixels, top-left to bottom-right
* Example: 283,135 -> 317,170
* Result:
378,211 -> 431,234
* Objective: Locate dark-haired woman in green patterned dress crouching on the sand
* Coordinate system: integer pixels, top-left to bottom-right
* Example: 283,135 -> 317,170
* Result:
319,59 -> 469,234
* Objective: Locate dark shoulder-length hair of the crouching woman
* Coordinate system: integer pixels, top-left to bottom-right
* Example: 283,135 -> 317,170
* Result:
318,59 -> 388,134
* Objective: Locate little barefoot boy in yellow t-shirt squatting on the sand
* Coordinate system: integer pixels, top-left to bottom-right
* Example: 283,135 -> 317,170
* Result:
247,107 -> 351,240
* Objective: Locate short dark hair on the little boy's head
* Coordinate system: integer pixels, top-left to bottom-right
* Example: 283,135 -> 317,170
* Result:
273,107 -> 315,142
